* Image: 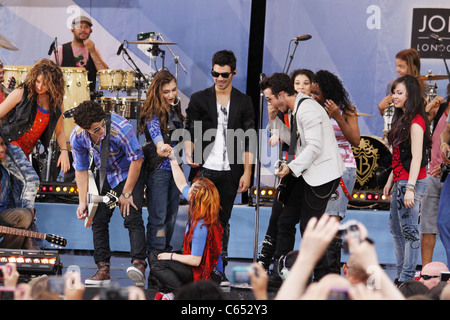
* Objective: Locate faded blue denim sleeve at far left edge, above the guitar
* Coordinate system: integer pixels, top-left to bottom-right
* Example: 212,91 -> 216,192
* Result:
3,144 -> 40,209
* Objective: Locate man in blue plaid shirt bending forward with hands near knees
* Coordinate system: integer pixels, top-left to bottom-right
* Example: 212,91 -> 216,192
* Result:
70,100 -> 146,286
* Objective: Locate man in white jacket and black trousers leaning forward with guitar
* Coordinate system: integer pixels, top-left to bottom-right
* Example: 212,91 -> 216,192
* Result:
260,73 -> 344,280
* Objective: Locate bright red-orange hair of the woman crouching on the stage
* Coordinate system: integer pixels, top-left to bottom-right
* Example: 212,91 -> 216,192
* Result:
189,178 -> 220,225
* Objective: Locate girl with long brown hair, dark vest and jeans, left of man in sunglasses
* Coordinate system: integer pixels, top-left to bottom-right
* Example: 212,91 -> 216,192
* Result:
139,70 -> 184,253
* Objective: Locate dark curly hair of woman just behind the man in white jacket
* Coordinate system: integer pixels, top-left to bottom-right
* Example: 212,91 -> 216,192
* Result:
313,70 -> 356,115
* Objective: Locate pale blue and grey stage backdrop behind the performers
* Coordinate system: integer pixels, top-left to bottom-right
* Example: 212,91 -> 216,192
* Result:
0,0 -> 450,184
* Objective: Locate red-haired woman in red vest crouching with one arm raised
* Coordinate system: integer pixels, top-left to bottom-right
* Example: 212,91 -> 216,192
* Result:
149,153 -> 223,300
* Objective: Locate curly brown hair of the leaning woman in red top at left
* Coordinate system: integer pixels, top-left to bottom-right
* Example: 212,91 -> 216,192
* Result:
20,59 -> 65,111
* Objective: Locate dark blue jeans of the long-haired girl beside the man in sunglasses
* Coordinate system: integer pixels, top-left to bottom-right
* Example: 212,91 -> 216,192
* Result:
146,170 -> 180,254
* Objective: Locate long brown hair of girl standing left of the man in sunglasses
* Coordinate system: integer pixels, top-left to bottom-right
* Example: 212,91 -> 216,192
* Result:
138,70 -> 184,134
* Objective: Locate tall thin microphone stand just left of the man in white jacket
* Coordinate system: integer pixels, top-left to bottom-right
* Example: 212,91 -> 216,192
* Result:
250,74 -> 264,262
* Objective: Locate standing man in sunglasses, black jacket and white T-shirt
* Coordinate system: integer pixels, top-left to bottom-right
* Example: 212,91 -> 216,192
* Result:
184,50 -> 255,285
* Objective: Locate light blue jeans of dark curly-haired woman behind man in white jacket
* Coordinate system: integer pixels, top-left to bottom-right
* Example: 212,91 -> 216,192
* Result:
325,168 -> 356,220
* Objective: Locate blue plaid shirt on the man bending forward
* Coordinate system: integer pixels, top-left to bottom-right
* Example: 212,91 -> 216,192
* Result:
70,114 -> 143,188
